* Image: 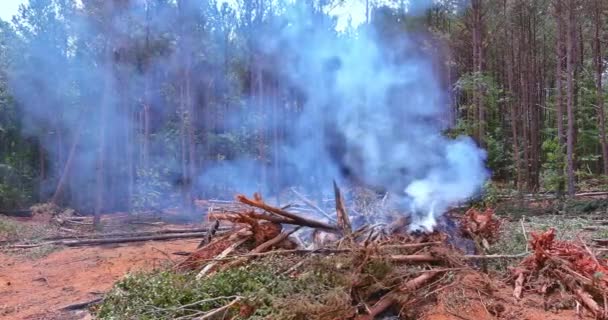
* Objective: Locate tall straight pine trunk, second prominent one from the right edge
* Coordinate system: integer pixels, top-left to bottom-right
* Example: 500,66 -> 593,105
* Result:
566,1 -> 576,197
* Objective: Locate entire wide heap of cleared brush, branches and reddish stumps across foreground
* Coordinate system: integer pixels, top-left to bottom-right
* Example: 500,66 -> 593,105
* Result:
98,187 -> 608,320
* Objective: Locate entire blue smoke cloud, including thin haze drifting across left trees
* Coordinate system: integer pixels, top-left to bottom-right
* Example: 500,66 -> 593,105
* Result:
5,0 -> 488,229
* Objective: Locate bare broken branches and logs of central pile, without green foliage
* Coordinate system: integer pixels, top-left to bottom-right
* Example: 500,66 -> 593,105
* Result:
175,187 -> 510,320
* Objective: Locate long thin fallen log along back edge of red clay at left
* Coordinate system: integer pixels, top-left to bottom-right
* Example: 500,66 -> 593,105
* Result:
7,232 -> 216,249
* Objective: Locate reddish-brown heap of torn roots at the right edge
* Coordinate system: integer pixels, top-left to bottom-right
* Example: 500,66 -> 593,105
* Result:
512,229 -> 608,319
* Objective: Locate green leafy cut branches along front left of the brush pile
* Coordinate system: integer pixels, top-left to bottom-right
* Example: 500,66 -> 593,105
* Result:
96,257 -> 372,319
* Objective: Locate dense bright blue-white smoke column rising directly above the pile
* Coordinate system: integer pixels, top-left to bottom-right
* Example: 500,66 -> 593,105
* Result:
204,3 -> 489,230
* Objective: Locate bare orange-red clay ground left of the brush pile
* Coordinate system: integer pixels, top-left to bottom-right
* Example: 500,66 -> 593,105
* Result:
0,239 -> 200,320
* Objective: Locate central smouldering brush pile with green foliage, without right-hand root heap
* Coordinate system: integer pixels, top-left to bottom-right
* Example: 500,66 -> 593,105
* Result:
100,187 -> 499,319
